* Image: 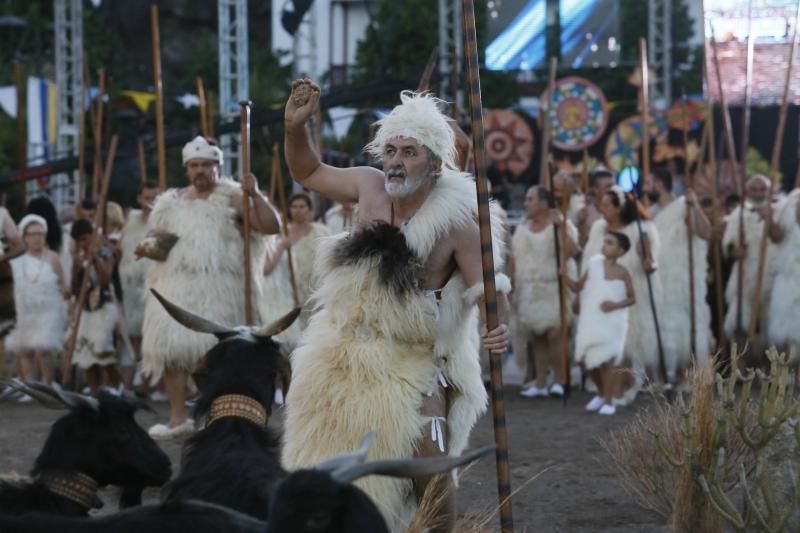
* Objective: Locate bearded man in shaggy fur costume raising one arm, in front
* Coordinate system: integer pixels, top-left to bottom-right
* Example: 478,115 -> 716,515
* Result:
283,80 -> 510,531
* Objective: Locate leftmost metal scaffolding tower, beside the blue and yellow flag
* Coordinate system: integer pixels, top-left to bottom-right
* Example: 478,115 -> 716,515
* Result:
51,0 -> 83,211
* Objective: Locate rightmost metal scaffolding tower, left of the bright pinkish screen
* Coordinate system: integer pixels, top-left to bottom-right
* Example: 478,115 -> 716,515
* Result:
647,0 -> 672,108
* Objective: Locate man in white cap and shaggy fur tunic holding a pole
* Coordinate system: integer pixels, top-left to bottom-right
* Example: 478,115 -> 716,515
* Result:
142,137 -> 280,439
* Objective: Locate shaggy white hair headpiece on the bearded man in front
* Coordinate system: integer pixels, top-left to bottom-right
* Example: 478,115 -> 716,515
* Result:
364,91 -> 457,169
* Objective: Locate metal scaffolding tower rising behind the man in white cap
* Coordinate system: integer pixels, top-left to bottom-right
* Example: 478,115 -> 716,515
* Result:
217,0 -> 250,176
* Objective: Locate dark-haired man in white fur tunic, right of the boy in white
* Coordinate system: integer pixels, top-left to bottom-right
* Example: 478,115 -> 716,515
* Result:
645,167 -> 714,375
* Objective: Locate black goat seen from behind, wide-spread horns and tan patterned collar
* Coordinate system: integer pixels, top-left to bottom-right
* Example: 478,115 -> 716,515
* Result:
153,291 -> 299,520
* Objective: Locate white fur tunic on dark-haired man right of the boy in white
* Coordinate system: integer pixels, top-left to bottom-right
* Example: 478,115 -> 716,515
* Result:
655,197 -> 714,371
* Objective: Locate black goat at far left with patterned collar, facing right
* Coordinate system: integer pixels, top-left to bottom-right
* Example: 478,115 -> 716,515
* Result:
0,380 -> 172,516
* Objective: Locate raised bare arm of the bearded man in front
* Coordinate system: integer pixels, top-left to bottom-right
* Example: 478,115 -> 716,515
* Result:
284,80 -> 374,202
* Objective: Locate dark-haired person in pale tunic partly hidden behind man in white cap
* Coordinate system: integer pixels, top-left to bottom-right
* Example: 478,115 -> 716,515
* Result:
119,181 -> 158,376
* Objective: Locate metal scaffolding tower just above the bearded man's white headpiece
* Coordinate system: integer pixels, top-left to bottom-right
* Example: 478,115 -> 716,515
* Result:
438,0 -> 464,115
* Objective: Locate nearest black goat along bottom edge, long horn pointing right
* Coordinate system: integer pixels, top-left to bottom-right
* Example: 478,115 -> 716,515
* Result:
0,443 -> 494,533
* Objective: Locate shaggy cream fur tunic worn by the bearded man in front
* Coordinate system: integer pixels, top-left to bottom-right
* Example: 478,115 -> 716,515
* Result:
283,170 -> 508,531
